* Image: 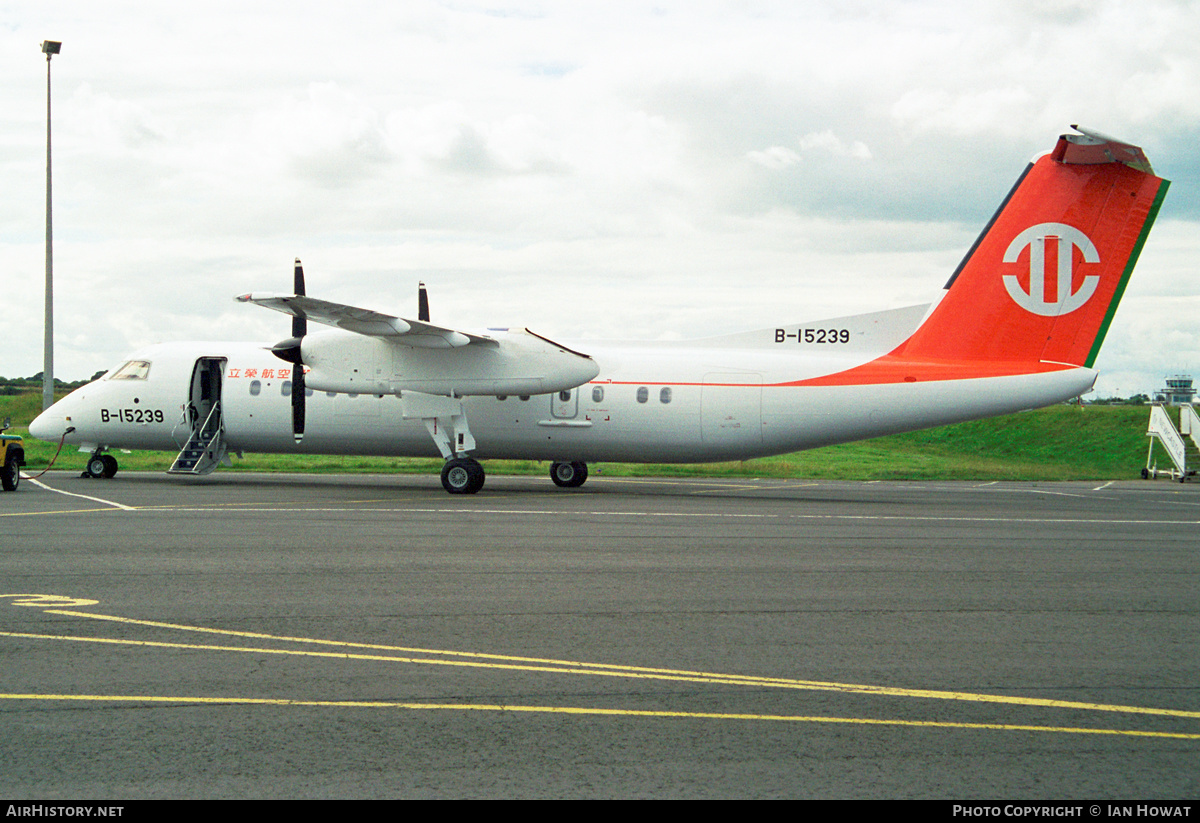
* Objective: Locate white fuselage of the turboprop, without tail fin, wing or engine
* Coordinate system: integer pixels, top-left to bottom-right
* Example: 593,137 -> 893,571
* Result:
30,319 -> 1096,462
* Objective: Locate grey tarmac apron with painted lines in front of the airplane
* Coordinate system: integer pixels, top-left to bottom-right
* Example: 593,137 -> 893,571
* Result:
0,473 -> 1200,800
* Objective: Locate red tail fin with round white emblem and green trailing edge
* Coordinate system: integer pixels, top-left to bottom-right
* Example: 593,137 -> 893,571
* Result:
894,130 -> 1169,367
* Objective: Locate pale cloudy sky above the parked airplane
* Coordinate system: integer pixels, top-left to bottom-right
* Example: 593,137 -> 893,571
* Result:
0,0 -> 1200,396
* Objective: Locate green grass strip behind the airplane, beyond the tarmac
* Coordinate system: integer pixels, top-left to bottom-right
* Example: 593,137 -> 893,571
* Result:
0,395 -> 1163,480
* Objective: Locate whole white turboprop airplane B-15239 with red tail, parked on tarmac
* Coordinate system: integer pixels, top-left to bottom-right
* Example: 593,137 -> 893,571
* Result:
29,127 -> 1169,494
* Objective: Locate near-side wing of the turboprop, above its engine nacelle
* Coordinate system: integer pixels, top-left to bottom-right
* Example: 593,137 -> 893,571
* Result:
236,293 -> 498,349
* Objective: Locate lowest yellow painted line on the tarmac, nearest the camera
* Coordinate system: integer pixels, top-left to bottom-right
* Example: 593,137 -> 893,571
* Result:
0,693 -> 1200,740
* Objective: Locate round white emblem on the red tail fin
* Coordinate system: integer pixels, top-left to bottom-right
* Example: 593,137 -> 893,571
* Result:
1003,223 -> 1100,317
